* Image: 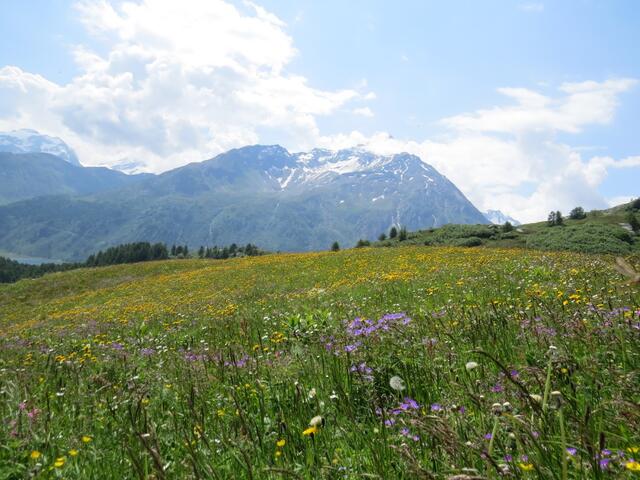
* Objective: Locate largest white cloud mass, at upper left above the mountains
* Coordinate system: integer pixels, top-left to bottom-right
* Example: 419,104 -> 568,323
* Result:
0,0 -> 375,171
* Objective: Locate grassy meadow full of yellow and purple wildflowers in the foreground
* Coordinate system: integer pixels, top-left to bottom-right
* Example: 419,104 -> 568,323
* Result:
0,246 -> 640,480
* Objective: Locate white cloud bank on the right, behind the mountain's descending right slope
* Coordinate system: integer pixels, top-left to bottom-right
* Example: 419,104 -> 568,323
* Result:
320,79 -> 640,222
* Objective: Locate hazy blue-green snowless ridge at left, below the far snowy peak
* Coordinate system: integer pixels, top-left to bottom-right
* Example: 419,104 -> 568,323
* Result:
0,152 -> 149,205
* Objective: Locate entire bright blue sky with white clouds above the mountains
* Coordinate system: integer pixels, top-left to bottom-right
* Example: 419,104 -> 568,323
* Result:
0,0 -> 640,221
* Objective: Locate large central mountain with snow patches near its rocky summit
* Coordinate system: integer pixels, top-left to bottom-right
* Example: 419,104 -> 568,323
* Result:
0,145 -> 487,259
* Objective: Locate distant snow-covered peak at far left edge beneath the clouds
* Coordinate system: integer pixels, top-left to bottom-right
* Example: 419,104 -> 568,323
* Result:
0,129 -> 81,166
